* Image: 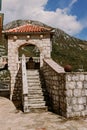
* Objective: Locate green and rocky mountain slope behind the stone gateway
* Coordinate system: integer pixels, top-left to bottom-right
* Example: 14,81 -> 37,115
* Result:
0,20 -> 87,71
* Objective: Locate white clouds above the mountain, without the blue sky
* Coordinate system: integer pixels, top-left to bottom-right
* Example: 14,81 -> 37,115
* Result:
2,0 -> 82,35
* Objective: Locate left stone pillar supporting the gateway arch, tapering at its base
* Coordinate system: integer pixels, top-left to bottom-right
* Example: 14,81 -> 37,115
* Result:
8,40 -> 18,100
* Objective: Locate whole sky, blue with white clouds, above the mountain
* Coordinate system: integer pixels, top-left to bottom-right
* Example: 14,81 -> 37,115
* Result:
0,0 -> 87,40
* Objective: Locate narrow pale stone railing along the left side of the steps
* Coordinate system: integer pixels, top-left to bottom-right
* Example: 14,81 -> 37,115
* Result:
22,55 -> 29,112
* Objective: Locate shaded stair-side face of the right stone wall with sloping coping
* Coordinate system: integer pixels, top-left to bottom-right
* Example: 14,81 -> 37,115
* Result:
43,59 -> 66,116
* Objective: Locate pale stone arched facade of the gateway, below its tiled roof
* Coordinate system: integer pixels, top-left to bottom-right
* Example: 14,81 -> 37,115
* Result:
8,34 -> 52,99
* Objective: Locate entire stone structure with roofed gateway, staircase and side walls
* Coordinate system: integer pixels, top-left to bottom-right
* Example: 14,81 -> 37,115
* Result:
4,24 -> 87,118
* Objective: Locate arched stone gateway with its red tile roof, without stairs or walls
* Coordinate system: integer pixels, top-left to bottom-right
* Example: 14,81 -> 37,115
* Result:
4,24 -> 52,103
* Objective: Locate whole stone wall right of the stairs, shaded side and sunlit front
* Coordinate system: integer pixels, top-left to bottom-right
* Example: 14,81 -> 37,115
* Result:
43,59 -> 87,118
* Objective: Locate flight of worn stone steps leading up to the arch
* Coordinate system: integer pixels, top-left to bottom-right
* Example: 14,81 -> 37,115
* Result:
27,70 -> 47,112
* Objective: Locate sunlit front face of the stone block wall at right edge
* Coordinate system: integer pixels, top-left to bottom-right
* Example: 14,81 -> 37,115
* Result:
65,72 -> 87,117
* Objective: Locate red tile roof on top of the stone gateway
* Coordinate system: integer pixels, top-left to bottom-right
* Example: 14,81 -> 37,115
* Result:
5,24 -> 51,33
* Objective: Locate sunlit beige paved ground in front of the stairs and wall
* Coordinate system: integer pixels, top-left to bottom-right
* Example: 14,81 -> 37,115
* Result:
0,97 -> 87,130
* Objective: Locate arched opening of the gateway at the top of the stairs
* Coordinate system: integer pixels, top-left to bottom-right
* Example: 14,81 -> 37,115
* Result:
18,44 -> 40,69
